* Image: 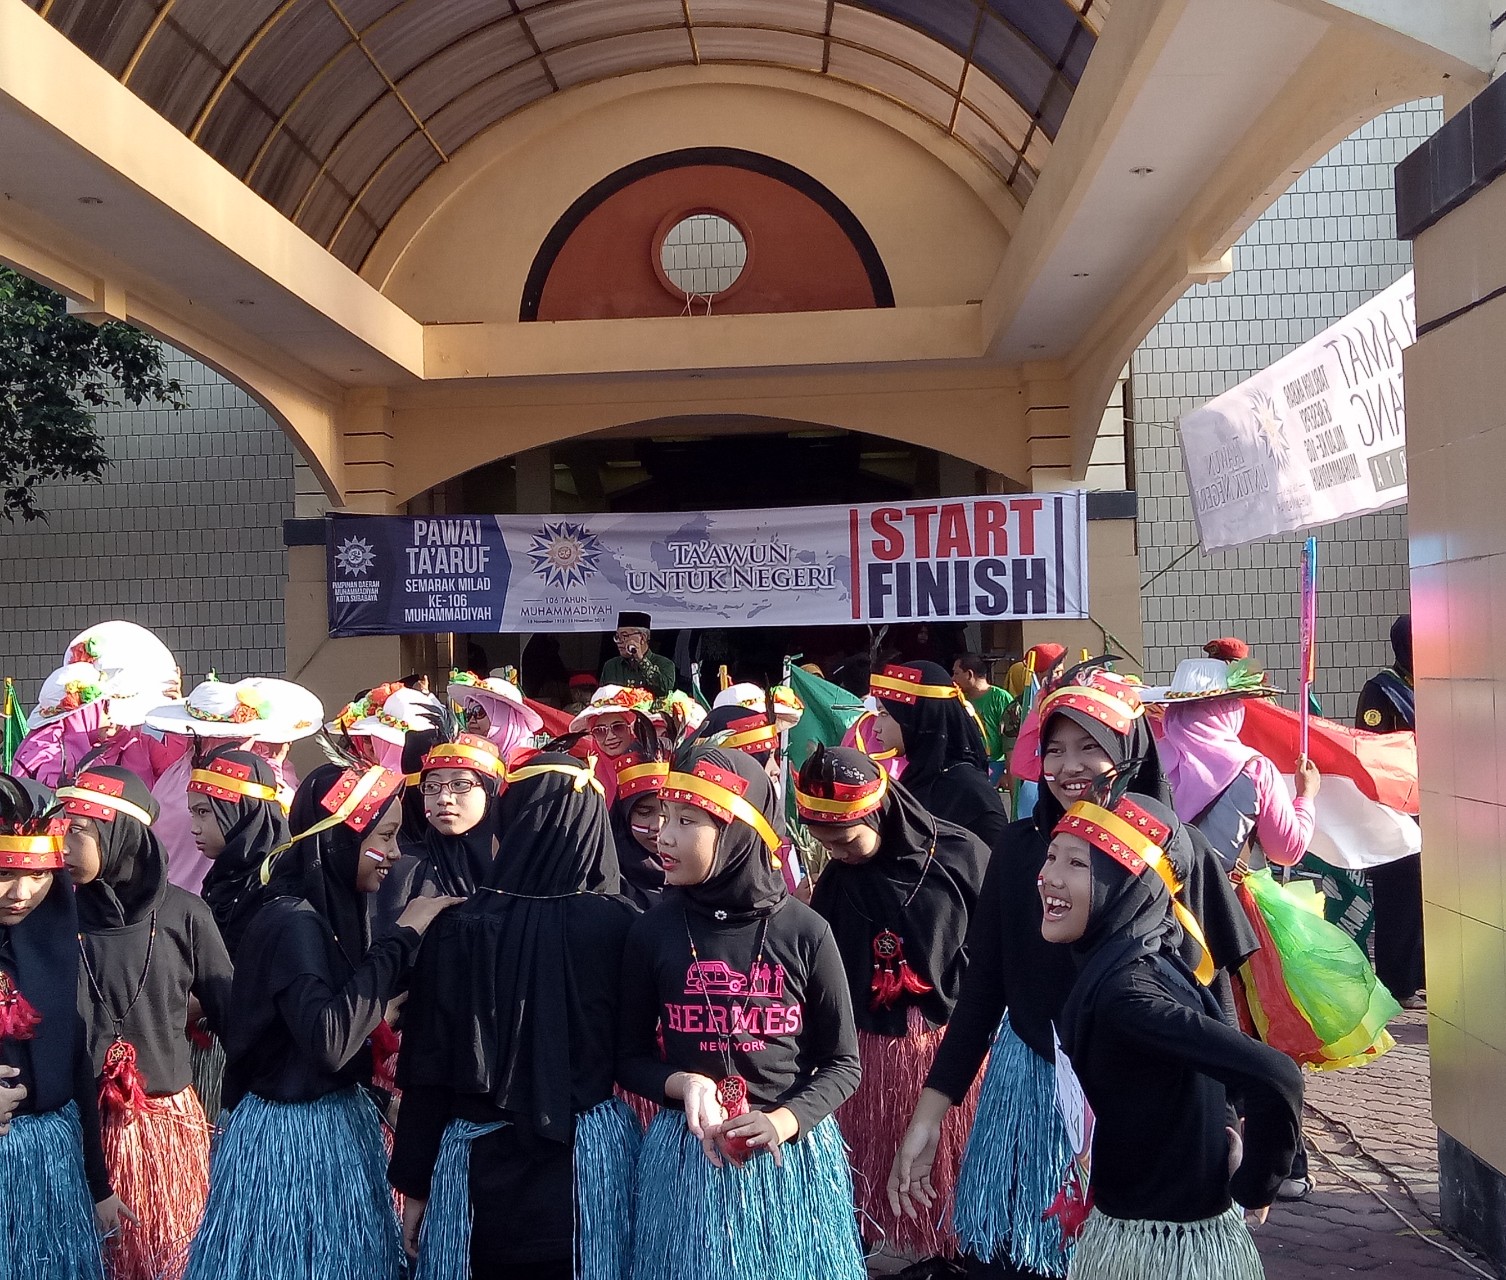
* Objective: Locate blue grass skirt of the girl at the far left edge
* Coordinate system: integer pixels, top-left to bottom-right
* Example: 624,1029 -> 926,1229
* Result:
0,1102 -> 104,1280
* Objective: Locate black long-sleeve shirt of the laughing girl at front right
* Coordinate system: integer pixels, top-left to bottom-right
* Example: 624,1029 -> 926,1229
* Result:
1072,958 -> 1303,1223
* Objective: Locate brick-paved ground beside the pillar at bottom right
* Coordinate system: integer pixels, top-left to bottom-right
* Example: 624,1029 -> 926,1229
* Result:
872,1012 -> 1500,1280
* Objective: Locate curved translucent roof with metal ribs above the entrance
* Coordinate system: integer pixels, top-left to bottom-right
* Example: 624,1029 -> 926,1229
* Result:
29,0 -> 1110,267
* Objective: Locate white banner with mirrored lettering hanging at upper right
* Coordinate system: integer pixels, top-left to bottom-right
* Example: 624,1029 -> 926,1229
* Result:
1181,271 -> 1417,551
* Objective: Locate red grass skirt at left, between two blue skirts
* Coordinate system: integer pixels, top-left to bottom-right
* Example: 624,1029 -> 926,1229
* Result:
101,1089 -> 209,1280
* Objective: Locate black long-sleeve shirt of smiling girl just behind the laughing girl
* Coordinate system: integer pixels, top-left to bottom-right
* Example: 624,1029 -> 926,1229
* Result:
926,818 -> 1077,1102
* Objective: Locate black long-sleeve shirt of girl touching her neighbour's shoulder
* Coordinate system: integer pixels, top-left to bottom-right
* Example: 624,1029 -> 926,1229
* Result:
224,898 -> 419,1107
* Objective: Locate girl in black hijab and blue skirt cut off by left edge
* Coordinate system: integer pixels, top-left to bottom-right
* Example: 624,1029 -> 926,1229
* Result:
0,774 -> 128,1280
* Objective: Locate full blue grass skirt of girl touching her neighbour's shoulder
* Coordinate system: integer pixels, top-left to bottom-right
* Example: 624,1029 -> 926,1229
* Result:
184,1087 -> 407,1280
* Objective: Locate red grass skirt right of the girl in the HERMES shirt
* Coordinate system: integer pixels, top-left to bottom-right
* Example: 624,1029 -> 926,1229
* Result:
837,1006 -> 983,1257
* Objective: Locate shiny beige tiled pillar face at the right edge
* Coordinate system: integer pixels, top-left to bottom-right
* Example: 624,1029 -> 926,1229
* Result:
1405,179 -> 1506,1172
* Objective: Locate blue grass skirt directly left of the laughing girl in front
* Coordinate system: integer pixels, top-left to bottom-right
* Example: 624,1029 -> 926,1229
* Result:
952,1018 -> 1072,1277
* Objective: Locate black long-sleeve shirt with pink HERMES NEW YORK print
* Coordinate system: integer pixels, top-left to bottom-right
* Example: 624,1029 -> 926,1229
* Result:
617,896 -> 861,1134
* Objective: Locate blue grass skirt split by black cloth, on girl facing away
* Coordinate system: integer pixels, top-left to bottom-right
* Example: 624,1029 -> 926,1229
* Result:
414,1098 -> 643,1280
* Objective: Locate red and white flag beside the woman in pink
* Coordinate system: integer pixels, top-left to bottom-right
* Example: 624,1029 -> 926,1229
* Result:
1239,699 -> 1422,870
